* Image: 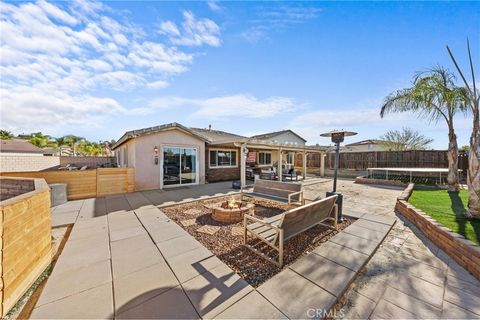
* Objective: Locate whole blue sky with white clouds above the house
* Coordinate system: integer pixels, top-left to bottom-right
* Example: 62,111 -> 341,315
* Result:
0,0 -> 480,149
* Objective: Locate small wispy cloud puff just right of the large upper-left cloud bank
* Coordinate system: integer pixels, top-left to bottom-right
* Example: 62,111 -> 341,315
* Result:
158,11 -> 220,47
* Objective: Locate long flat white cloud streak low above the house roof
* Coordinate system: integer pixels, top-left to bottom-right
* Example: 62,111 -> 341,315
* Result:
144,94 -> 296,118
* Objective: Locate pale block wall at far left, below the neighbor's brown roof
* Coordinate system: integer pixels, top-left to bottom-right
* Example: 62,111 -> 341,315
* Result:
0,154 -> 60,172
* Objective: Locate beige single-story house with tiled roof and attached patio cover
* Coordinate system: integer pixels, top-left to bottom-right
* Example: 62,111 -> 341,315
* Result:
112,123 -> 325,190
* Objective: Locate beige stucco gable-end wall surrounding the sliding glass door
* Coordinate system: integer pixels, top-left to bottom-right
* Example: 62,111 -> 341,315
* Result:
132,129 -> 205,190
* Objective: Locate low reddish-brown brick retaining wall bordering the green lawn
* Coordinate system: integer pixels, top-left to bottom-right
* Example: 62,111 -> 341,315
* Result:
395,198 -> 480,280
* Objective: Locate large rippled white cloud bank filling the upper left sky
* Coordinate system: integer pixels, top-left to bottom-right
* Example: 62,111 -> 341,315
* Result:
0,0 -> 220,132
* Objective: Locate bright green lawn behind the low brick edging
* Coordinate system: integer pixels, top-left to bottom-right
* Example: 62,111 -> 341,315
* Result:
408,186 -> 480,245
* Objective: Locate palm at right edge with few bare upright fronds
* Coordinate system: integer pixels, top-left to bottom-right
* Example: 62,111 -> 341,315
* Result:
447,39 -> 480,219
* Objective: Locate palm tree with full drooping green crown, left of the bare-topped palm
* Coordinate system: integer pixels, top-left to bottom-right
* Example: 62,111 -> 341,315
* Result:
380,67 -> 468,191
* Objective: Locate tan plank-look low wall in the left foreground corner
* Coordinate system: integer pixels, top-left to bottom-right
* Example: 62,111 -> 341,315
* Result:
0,179 -> 52,317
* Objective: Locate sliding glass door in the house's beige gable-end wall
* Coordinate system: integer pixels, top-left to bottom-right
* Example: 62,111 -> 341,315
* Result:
163,147 -> 197,186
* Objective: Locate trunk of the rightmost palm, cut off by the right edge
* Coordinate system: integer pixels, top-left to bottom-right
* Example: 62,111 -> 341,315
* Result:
467,106 -> 480,219
